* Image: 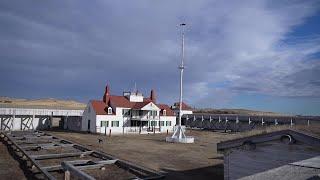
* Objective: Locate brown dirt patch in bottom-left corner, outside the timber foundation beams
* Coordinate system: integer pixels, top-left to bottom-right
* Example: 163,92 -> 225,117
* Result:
0,141 -> 27,180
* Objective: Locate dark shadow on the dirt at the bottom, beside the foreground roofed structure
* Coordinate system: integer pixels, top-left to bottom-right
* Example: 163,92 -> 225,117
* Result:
162,164 -> 223,180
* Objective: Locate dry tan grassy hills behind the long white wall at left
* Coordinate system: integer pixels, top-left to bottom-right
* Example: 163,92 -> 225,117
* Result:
0,96 -> 86,109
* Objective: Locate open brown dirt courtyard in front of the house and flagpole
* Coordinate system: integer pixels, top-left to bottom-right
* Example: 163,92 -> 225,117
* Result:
49,130 -> 242,179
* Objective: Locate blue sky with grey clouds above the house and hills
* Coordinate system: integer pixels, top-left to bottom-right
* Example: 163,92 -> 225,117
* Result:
0,0 -> 320,115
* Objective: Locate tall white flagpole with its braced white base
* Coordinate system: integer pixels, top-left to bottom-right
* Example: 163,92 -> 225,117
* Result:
166,23 -> 194,143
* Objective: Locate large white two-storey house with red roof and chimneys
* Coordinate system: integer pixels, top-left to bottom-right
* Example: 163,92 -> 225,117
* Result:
81,86 -> 176,134
